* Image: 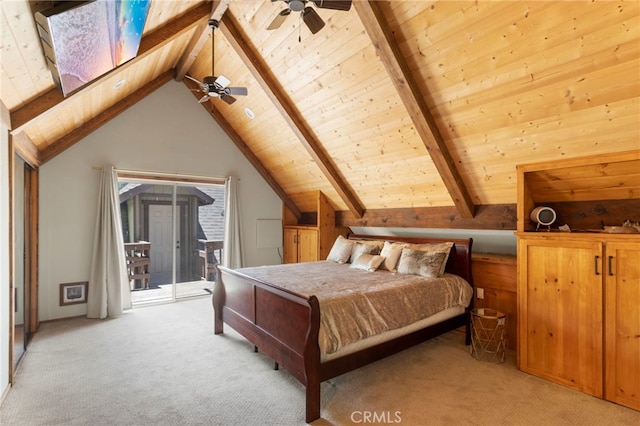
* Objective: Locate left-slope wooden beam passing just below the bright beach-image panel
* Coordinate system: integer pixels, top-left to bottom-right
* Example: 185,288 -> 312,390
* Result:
10,3 -> 210,134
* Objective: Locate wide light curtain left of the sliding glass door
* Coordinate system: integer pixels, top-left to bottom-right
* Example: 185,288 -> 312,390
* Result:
87,167 -> 131,318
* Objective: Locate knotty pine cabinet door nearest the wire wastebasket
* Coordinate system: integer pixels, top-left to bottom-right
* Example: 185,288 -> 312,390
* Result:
518,238 -> 603,397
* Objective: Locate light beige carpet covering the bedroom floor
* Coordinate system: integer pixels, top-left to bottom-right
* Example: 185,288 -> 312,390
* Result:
0,297 -> 640,426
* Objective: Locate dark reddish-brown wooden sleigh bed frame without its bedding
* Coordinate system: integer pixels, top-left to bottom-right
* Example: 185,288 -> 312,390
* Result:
212,235 -> 473,423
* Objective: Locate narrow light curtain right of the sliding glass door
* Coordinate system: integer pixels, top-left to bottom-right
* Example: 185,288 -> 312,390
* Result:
222,176 -> 244,269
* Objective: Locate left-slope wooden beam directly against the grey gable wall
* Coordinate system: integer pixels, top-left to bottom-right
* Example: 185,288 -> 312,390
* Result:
40,69 -> 175,163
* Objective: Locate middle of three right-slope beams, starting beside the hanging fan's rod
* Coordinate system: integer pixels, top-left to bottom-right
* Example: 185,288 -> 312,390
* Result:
220,11 -> 364,217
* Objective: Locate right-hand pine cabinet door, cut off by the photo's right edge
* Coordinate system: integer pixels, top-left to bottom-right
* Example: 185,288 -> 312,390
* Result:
605,243 -> 640,410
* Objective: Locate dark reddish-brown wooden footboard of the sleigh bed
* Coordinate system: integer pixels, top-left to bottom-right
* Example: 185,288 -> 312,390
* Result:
212,265 -> 320,422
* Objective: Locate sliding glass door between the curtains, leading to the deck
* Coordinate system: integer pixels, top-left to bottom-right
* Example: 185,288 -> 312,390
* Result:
120,179 -> 224,306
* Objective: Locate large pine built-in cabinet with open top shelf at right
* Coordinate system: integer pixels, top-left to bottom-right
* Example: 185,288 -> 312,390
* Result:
516,151 -> 640,410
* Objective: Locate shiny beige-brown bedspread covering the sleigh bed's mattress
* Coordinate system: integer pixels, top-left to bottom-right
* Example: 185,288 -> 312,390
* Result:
238,261 -> 473,354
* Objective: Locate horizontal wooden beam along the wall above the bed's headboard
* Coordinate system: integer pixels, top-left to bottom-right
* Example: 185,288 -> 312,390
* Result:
336,204 -> 516,230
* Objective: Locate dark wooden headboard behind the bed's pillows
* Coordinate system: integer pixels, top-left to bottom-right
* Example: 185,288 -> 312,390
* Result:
348,234 -> 473,286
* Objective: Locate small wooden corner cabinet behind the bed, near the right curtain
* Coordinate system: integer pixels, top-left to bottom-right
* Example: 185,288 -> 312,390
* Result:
283,191 -> 346,263
